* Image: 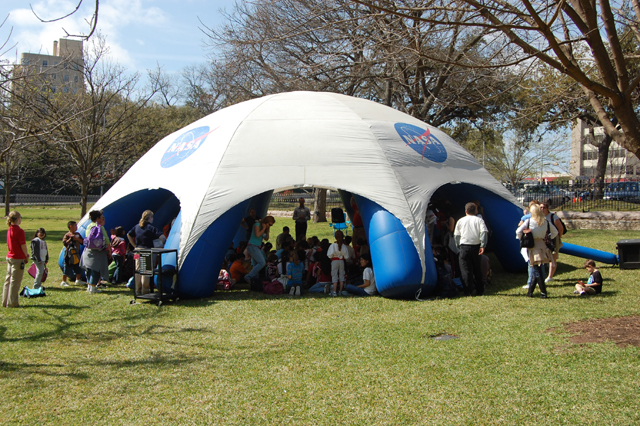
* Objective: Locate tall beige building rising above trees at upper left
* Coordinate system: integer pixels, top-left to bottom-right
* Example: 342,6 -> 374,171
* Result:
16,38 -> 84,94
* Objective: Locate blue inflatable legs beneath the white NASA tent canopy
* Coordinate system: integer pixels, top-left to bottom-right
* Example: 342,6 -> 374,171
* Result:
67,183 -> 526,298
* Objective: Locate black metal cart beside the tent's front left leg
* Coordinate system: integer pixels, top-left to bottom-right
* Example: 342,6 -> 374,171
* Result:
131,248 -> 179,306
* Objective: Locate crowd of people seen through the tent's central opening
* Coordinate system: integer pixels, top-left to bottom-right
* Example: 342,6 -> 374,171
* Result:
218,198 -> 377,296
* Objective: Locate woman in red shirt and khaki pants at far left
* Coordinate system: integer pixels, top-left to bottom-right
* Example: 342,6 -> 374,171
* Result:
2,210 -> 29,308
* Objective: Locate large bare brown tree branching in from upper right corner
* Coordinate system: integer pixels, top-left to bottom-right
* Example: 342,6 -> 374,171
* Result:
353,0 -> 640,161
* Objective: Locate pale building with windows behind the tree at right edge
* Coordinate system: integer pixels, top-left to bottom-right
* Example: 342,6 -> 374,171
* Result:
570,119 -> 640,182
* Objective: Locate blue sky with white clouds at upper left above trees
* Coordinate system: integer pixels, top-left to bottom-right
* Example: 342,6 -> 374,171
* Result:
0,0 -> 235,74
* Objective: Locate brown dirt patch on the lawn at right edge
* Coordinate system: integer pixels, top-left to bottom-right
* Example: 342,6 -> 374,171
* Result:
547,315 -> 640,347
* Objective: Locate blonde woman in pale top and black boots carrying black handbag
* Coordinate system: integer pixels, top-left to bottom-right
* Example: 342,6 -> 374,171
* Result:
516,204 -> 558,299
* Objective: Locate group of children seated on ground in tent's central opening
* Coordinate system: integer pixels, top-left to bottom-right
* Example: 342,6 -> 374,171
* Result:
224,230 -> 377,296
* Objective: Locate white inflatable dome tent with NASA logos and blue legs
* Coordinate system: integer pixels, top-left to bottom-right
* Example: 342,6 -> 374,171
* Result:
80,92 -> 525,298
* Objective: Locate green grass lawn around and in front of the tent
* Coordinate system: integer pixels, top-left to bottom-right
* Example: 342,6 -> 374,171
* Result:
0,208 -> 640,425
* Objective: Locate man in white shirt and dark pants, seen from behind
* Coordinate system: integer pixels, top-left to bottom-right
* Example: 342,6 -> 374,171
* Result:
453,203 -> 489,296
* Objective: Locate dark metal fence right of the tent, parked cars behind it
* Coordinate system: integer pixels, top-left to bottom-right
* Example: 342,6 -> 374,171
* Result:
511,181 -> 640,212
